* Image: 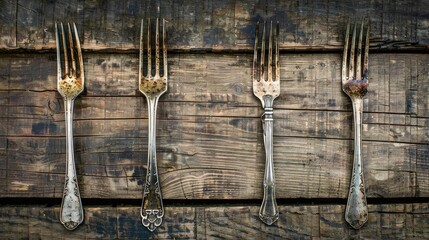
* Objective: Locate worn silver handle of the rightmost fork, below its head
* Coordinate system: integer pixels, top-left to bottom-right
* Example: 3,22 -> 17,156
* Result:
345,96 -> 368,229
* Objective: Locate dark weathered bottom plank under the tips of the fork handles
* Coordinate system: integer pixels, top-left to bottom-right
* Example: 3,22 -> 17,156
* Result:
0,203 -> 429,239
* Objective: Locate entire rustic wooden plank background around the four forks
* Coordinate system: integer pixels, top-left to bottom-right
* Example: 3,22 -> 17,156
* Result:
0,0 -> 429,239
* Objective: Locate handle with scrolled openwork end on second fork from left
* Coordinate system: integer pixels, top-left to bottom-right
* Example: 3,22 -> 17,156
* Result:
140,97 -> 164,231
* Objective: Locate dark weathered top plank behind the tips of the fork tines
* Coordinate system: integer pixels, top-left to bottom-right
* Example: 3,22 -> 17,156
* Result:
0,0 -> 429,51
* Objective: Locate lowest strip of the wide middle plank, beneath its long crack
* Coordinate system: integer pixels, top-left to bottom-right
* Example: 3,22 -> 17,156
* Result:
0,135 -> 429,199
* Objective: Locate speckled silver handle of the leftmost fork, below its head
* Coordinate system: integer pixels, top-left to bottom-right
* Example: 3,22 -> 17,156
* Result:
60,98 -> 83,230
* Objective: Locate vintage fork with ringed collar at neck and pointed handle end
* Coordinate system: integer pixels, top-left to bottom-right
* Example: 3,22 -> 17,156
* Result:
252,22 -> 280,225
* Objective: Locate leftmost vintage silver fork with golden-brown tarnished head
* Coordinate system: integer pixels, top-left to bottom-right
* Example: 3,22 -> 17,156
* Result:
55,23 -> 84,230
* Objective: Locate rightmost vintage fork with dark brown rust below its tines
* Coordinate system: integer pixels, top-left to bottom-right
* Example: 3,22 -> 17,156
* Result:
341,21 -> 370,229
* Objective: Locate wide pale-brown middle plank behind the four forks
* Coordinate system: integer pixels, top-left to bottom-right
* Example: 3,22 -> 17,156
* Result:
0,54 -> 429,199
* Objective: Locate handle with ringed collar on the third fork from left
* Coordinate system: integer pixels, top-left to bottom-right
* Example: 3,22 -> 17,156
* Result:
259,95 -> 279,225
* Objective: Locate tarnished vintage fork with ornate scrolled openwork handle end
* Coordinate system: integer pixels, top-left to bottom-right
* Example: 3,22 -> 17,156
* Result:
139,18 -> 168,231
